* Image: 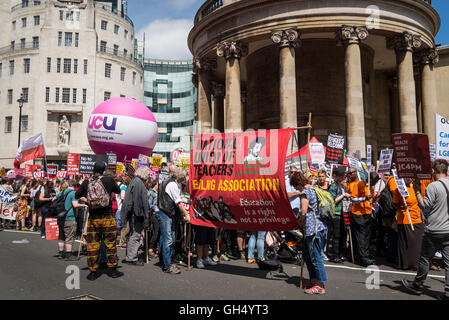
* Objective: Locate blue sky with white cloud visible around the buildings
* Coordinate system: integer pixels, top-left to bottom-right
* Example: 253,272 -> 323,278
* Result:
128,0 -> 449,60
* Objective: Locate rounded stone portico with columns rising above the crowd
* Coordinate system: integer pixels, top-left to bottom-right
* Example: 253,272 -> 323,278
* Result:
188,0 -> 442,159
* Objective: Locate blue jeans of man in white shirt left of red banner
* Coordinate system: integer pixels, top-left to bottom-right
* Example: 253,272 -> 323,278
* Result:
156,211 -> 176,270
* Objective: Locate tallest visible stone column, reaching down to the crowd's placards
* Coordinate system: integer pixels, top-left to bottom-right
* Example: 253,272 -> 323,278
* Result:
339,26 -> 368,158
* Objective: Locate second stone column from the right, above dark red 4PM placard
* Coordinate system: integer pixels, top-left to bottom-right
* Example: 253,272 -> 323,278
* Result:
387,32 -> 421,133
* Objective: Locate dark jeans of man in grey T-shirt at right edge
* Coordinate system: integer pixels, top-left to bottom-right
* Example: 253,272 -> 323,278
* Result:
415,233 -> 449,298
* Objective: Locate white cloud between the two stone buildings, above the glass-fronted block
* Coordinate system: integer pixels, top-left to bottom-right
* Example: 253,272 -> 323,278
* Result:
137,19 -> 193,60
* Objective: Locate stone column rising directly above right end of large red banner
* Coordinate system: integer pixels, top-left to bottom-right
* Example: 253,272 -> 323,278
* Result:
271,29 -> 300,129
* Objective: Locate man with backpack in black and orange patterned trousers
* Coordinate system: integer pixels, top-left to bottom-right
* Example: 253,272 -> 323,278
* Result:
75,161 -> 123,281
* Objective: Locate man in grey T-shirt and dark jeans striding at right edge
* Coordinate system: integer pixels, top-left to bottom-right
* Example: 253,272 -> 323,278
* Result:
402,159 -> 449,301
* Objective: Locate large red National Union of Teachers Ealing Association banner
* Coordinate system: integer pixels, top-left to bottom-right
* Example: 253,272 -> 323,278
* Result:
190,129 -> 298,231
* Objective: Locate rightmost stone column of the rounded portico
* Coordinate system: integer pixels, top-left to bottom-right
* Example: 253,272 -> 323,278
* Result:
419,48 -> 439,144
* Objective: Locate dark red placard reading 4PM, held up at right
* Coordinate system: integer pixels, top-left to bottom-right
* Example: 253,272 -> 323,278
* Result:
392,133 -> 432,179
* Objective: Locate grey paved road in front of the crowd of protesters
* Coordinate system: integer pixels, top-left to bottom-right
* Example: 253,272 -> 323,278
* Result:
0,231 -> 444,300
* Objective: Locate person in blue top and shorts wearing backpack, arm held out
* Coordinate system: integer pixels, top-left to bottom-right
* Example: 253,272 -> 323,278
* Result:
54,180 -> 87,261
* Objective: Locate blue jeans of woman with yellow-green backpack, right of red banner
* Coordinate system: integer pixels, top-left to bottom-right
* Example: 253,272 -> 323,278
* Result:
303,230 -> 327,283
